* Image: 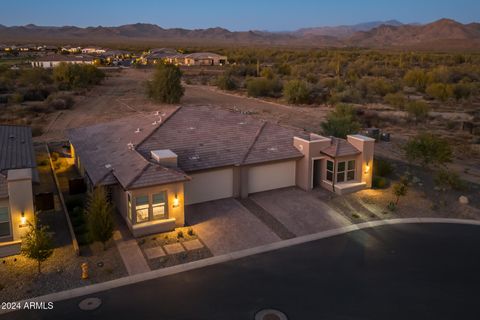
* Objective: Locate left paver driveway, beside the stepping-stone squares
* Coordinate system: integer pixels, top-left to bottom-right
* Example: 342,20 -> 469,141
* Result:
185,198 -> 280,255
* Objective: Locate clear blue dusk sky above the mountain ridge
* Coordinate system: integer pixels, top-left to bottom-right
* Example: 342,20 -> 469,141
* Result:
0,0 -> 480,31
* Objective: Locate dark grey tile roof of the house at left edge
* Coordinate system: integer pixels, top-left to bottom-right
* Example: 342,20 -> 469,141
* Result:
0,125 -> 37,172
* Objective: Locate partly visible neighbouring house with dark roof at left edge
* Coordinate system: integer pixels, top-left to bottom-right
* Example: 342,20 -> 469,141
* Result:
0,125 -> 38,257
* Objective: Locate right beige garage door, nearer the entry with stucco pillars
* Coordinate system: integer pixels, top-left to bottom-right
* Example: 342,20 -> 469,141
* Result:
248,161 -> 296,193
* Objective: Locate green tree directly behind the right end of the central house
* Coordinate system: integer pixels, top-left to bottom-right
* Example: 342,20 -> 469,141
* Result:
321,104 -> 360,138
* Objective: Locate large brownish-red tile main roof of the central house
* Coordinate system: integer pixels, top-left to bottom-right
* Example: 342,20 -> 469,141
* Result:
68,107 -> 309,188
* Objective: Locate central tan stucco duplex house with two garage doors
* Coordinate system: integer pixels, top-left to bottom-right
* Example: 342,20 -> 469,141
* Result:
68,107 -> 374,236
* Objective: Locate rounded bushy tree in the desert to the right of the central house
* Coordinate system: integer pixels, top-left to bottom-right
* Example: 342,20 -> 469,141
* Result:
403,133 -> 453,167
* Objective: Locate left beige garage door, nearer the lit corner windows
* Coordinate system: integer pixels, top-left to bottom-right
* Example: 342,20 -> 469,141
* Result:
185,168 -> 233,204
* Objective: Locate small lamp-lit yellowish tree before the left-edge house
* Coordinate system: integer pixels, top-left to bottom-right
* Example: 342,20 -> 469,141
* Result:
21,219 -> 53,274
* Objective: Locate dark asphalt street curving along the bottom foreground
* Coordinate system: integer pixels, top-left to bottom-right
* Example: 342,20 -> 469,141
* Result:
0,224 -> 480,320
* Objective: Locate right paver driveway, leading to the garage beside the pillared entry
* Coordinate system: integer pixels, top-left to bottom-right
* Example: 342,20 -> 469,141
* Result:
250,188 -> 351,236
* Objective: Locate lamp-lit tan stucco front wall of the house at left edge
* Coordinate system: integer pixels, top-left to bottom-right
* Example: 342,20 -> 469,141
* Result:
7,169 -> 34,240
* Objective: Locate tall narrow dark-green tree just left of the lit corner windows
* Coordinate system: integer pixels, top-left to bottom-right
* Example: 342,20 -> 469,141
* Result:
86,187 -> 114,250
